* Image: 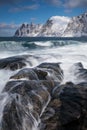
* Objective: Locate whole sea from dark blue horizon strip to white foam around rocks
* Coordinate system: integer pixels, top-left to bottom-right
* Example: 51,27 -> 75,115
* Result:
0,37 -> 87,129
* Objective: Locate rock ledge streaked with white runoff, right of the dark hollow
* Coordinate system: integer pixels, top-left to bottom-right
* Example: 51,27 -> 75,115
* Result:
37,63 -> 63,82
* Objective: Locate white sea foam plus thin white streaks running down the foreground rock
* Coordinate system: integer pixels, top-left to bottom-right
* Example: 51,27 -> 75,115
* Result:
0,42 -> 87,130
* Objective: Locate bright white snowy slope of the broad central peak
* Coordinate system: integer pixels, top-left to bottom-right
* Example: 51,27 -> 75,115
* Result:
39,16 -> 70,37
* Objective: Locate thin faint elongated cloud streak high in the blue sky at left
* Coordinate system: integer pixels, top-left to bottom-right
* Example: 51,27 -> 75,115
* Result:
10,4 -> 39,12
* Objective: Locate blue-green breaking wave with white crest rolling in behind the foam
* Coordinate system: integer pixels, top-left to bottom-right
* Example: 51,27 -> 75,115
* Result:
0,40 -> 81,51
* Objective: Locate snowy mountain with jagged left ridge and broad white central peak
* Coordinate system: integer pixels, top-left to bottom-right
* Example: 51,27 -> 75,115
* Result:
15,16 -> 70,37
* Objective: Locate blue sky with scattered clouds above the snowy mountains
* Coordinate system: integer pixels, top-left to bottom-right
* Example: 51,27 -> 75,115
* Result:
0,0 -> 87,36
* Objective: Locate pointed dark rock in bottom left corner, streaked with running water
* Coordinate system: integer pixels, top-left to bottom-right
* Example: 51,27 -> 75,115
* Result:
1,96 -> 34,130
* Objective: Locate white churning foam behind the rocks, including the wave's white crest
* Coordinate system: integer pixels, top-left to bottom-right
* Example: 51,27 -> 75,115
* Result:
0,41 -> 87,84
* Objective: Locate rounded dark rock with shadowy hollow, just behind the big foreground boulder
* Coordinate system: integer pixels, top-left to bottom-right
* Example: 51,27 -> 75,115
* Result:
9,65 -> 58,94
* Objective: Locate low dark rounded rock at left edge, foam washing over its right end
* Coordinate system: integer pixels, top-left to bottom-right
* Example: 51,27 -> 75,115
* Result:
0,55 -> 40,70
